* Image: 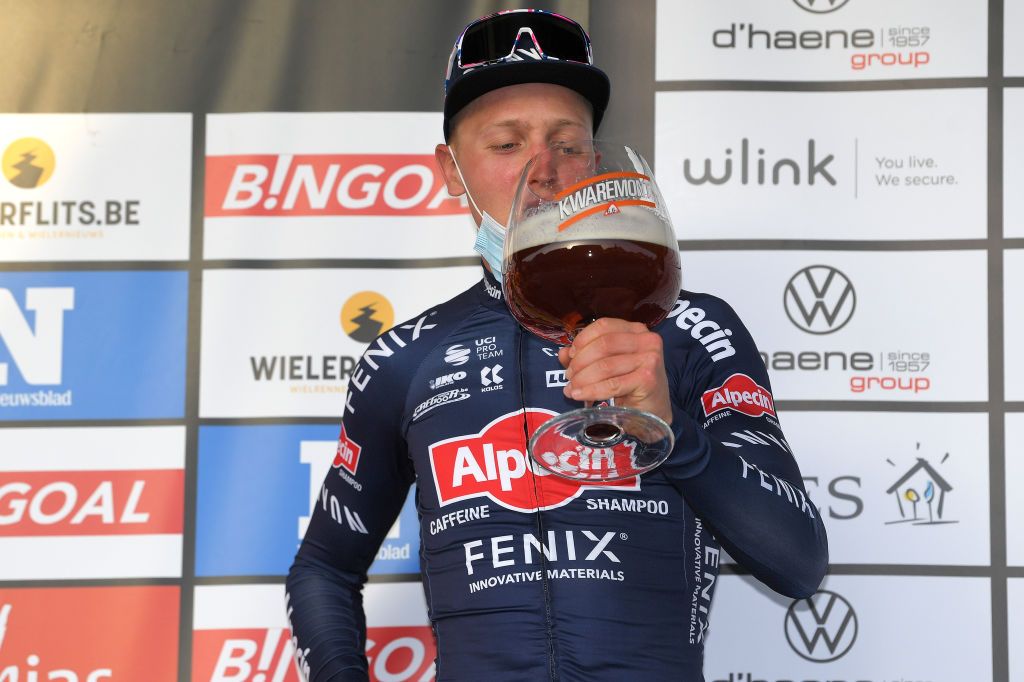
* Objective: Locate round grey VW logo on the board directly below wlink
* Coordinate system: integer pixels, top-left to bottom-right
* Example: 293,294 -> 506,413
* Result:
782,265 -> 857,334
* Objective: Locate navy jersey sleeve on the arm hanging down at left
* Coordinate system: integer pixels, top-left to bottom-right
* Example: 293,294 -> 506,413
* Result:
286,339 -> 415,682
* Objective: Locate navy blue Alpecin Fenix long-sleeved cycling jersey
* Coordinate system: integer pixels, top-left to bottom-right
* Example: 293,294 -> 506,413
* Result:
287,273 -> 827,682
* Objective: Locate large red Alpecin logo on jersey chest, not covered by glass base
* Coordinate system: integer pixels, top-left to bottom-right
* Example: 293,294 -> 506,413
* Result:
428,408 -> 640,513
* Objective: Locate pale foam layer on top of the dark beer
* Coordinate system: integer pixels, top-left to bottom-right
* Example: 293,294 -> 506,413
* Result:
506,204 -> 676,251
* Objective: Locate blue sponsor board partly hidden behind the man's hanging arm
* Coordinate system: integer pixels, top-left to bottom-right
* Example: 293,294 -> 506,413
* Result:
196,424 -> 420,576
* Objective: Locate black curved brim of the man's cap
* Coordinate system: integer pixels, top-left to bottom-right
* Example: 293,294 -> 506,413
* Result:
444,60 -> 611,140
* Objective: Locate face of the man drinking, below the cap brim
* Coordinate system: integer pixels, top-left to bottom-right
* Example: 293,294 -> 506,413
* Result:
434,83 -> 593,223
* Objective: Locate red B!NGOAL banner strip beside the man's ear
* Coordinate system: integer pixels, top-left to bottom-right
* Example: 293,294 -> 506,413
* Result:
206,154 -> 469,217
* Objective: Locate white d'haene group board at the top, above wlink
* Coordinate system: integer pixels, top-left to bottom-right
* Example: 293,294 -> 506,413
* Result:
656,0 -> 987,81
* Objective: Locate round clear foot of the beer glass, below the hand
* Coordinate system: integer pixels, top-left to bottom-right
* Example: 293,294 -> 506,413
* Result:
529,406 -> 675,481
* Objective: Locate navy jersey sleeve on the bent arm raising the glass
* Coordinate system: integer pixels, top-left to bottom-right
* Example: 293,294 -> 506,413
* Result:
660,297 -> 828,598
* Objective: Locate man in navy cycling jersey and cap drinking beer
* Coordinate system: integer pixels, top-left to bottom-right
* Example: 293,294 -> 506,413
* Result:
287,10 -> 827,682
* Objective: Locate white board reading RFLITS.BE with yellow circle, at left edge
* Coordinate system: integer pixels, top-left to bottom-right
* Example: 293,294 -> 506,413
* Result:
0,114 -> 191,262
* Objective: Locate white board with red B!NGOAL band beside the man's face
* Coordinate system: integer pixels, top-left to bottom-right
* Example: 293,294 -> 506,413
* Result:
203,112 -> 473,258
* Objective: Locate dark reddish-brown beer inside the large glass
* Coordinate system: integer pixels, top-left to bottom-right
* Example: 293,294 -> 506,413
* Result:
504,239 -> 679,344
